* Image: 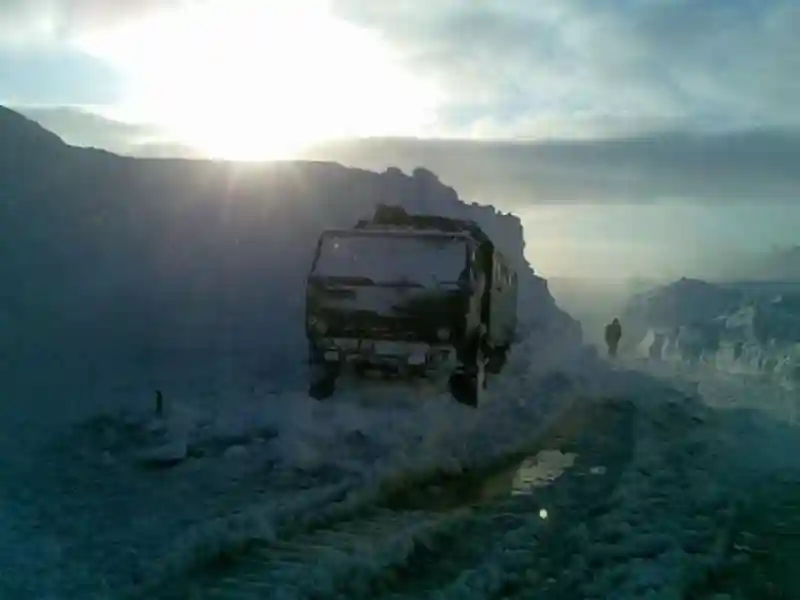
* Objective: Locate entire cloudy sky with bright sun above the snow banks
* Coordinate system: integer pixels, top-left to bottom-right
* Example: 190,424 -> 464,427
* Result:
0,0 -> 800,276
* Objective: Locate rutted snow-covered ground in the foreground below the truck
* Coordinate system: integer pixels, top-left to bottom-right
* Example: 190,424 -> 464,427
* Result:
3,338 -> 752,598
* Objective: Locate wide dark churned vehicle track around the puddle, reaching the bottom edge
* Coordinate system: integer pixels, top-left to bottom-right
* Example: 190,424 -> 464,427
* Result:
132,400 -> 635,599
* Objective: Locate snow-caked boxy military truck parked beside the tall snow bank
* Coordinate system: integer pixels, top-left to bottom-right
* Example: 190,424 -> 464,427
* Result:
305,205 -> 517,407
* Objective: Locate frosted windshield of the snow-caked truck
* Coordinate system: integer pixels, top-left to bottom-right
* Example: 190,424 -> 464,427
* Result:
314,234 -> 467,287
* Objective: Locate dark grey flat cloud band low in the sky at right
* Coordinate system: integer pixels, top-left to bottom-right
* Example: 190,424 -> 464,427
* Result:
304,130 -> 800,209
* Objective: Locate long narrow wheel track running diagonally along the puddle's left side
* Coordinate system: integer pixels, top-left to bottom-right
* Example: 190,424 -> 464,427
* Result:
125,390 -> 581,597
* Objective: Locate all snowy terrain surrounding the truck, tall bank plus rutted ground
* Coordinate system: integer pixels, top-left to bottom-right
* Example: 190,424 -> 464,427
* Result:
0,112 -> 798,600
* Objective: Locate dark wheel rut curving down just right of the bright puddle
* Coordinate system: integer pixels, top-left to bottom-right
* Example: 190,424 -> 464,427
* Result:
368,401 -> 635,600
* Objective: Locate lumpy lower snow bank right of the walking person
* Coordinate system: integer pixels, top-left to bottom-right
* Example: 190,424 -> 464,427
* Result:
624,278 -> 800,385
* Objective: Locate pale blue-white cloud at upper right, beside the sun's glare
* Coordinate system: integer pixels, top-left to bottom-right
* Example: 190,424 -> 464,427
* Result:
334,0 -> 800,138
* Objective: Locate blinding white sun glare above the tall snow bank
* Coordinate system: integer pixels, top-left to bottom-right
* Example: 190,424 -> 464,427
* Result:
78,0 -> 439,160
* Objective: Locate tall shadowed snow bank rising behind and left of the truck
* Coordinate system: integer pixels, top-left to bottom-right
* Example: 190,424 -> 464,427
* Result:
0,109 -> 580,426
